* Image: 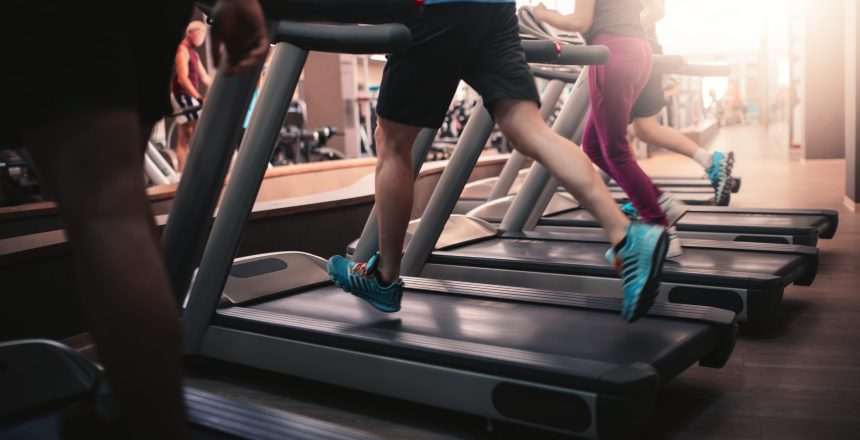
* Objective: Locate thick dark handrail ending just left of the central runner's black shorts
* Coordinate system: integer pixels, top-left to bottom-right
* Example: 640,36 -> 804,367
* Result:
273,20 -> 412,54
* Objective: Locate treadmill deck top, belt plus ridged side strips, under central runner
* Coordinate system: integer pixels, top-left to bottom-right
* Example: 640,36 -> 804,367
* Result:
215,278 -> 735,392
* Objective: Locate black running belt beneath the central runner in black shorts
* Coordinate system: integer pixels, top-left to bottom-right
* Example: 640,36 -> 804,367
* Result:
216,285 -> 717,392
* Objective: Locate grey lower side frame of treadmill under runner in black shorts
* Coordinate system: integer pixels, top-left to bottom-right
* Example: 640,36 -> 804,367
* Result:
202,325 -> 612,439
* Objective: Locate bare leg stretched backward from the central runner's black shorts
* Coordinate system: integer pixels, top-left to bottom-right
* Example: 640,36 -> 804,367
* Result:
493,99 -> 630,246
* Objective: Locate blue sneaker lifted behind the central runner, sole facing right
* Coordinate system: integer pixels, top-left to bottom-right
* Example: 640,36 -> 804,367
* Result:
606,222 -> 668,322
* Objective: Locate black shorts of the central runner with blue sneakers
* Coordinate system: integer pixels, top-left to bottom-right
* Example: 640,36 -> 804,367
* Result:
376,3 -> 540,128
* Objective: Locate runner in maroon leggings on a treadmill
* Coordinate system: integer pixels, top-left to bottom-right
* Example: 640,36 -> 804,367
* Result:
534,0 -> 684,258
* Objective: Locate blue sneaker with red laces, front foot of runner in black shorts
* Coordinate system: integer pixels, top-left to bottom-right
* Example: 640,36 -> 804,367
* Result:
328,252 -> 403,313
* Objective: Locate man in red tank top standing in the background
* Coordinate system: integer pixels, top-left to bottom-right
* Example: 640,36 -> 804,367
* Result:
170,20 -> 212,172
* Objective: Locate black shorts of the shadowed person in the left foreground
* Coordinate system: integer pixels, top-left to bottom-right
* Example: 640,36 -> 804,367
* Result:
0,0 -> 192,145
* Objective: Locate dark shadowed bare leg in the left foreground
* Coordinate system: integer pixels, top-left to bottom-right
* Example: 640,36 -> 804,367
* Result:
24,110 -> 189,439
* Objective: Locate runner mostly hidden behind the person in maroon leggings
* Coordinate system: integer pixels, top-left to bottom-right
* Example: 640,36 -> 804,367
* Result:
621,0 -> 734,206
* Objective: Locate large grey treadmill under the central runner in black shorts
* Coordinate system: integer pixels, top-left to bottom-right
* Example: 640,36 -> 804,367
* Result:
164,9 -> 736,438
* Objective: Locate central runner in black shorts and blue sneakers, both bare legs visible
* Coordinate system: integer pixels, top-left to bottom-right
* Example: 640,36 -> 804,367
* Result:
328,0 -> 667,322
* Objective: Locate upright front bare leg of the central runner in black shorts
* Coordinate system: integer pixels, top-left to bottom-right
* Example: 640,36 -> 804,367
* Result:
376,118 -> 421,283
